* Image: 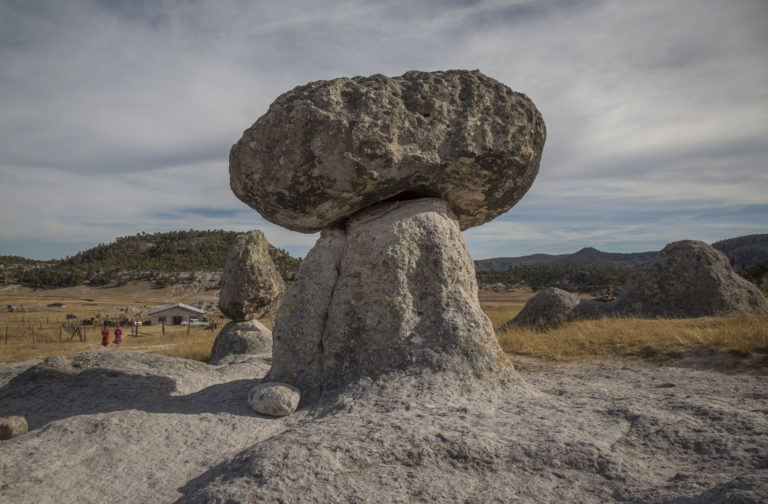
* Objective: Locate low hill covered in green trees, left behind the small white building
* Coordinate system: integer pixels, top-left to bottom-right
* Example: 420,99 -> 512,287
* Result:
0,230 -> 301,287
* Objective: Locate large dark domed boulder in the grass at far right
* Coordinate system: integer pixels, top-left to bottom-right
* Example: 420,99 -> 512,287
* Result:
615,240 -> 768,317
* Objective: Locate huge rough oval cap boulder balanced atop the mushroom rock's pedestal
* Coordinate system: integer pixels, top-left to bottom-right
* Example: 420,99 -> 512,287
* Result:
229,70 -> 546,232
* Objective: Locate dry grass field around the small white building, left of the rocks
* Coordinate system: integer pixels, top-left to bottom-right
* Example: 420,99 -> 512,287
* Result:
0,282 -> 234,362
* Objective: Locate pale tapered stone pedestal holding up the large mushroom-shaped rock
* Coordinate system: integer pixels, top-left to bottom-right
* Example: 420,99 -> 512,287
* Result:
270,198 -> 507,393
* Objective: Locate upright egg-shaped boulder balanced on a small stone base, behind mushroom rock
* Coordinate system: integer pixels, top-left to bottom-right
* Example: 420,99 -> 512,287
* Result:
219,231 -> 285,322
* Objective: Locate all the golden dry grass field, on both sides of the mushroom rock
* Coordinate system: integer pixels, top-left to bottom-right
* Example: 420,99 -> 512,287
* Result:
0,282 -> 768,372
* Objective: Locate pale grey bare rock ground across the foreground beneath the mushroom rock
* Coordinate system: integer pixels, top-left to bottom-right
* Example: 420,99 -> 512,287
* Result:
0,352 -> 768,503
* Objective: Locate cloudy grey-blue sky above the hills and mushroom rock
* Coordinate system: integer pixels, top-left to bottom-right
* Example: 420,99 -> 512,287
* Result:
0,0 -> 768,259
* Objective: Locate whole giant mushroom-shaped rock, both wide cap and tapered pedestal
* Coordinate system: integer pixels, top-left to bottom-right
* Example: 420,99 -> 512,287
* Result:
230,70 -> 546,395
